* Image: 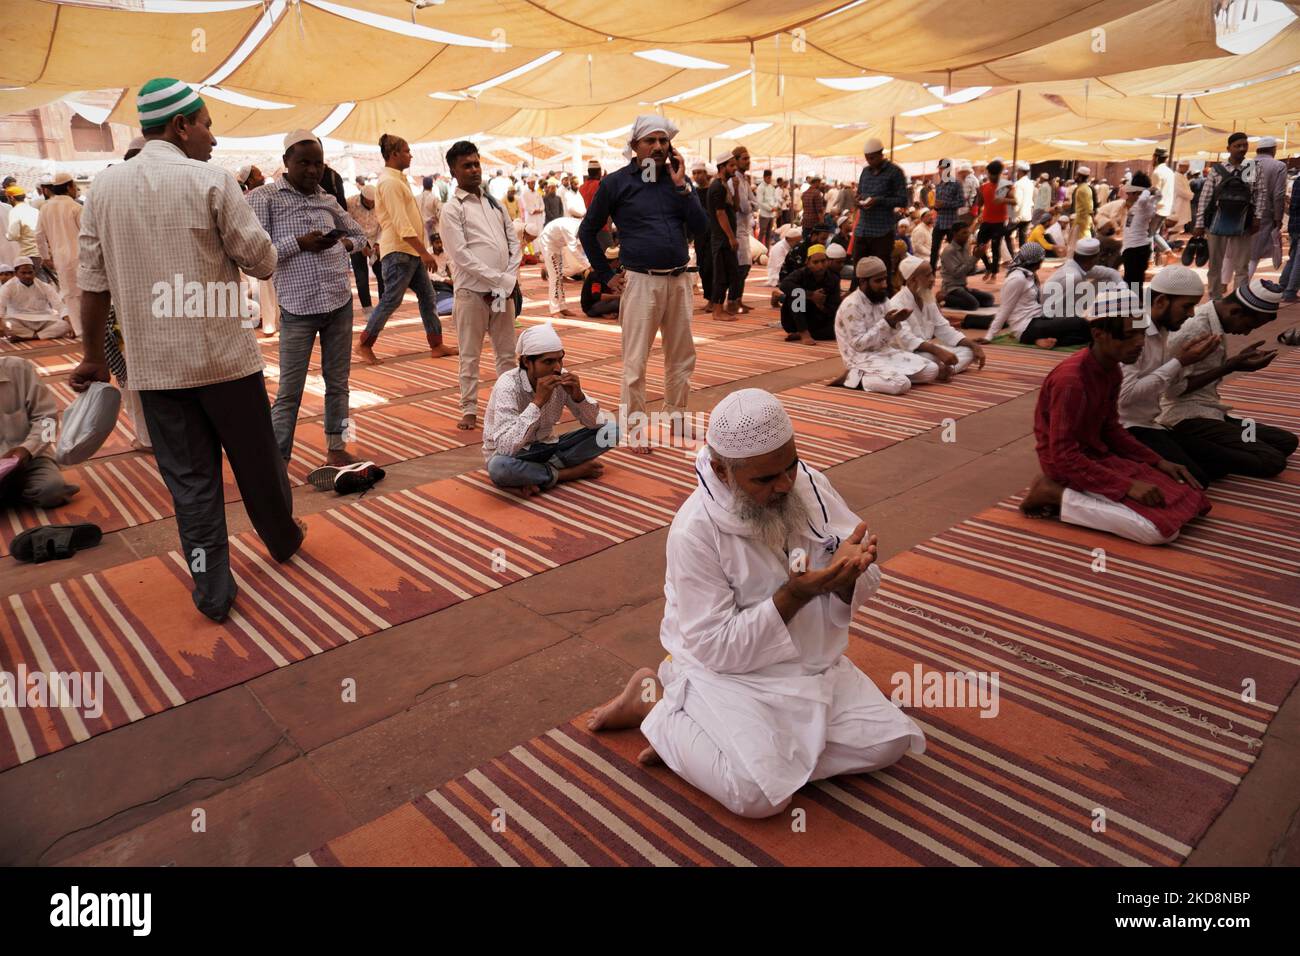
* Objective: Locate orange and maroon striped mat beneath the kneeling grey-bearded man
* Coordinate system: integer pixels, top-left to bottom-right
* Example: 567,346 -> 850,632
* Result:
294,467 -> 1300,866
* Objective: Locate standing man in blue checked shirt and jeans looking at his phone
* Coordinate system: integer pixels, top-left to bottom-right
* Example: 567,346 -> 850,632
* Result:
248,130 -> 367,466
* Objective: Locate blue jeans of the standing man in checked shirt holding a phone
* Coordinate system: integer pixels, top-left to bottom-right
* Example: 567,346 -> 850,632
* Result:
270,298 -> 352,462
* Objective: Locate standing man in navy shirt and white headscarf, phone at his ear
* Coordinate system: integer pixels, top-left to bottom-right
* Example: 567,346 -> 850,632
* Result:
577,114 -> 707,454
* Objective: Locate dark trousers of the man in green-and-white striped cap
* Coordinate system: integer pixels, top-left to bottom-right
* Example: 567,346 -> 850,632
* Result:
140,372 -> 303,620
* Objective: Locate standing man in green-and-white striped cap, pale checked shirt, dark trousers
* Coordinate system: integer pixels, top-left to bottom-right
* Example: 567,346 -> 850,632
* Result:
72,79 -> 307,622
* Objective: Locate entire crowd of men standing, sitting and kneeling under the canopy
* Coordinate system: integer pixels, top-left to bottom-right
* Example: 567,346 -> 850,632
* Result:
0,78 -> 1300,816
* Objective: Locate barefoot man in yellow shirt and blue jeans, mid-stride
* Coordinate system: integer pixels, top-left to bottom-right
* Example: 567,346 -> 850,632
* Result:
356,133 -> 456,365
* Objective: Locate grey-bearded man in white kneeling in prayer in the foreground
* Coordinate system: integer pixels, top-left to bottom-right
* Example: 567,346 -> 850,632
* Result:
588,389 -> 926,818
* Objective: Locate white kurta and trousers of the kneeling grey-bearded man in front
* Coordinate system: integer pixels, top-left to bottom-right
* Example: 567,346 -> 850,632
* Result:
641,449 -> 926,817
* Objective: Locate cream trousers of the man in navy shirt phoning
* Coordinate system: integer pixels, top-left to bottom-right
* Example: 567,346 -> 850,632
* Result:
619,271 -> 696,415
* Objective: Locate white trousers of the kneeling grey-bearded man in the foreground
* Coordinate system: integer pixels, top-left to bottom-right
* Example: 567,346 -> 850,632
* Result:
654,669 -> 911,819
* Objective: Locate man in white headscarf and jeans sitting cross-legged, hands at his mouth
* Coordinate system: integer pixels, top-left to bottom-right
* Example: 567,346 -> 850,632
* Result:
484,324 -> 619,498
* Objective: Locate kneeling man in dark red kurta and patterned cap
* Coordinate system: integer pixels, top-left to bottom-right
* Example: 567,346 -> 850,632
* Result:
1021,286 -> 1210,545
